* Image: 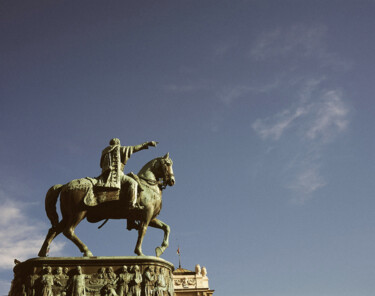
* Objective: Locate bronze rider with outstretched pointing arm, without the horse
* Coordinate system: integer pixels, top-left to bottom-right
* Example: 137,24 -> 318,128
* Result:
96,138 -> 157,209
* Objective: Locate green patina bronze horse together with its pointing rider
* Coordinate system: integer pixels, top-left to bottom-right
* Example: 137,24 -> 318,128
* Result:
38,139 -> 175,257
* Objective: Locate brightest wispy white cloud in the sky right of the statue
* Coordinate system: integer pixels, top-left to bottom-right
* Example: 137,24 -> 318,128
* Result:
252,79 -> 349,202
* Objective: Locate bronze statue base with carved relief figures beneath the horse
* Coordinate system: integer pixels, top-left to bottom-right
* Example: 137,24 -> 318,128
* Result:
9,256 -> 174,296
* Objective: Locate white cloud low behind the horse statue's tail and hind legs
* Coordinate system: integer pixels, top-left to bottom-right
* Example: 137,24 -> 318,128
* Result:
0,199 -> 64,269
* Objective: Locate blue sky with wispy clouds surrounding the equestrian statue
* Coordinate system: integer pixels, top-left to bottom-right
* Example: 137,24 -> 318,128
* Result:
0,0 -> 375,296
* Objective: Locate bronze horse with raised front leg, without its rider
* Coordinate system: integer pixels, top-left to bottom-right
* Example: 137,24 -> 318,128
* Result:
38,153 -> 175,257
